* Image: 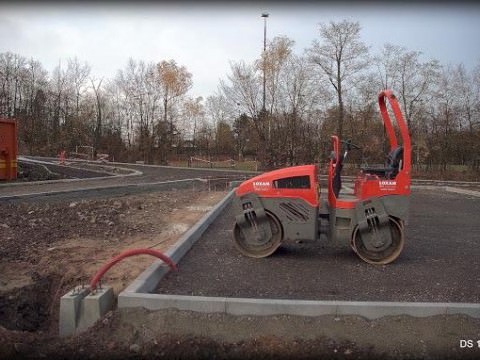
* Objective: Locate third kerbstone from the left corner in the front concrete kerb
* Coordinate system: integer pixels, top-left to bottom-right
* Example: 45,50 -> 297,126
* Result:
337,301 -> 447,319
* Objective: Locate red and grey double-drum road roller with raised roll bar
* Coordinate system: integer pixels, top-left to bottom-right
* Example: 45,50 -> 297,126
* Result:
233,90 -> 411,264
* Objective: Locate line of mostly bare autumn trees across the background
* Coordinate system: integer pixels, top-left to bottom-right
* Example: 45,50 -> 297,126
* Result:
0,20 -> 480,171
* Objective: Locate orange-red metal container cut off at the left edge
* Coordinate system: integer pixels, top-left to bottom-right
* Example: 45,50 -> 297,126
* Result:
0,119 -> 17,180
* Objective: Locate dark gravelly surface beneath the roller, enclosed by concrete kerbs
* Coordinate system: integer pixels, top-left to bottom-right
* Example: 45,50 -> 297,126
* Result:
157,188 -> 480,303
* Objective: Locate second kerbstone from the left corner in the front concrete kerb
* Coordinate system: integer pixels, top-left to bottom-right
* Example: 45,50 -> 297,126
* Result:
225,298 -> 336,316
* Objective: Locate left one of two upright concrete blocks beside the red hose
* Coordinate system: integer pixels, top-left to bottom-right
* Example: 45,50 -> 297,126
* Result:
58,286 -> 90,336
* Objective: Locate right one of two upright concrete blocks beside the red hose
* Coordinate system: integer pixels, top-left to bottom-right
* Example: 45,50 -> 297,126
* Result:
77,286 -> 115,332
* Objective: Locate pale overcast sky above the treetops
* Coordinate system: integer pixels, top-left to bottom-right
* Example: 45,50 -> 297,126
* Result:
0,1 -> 480,97
